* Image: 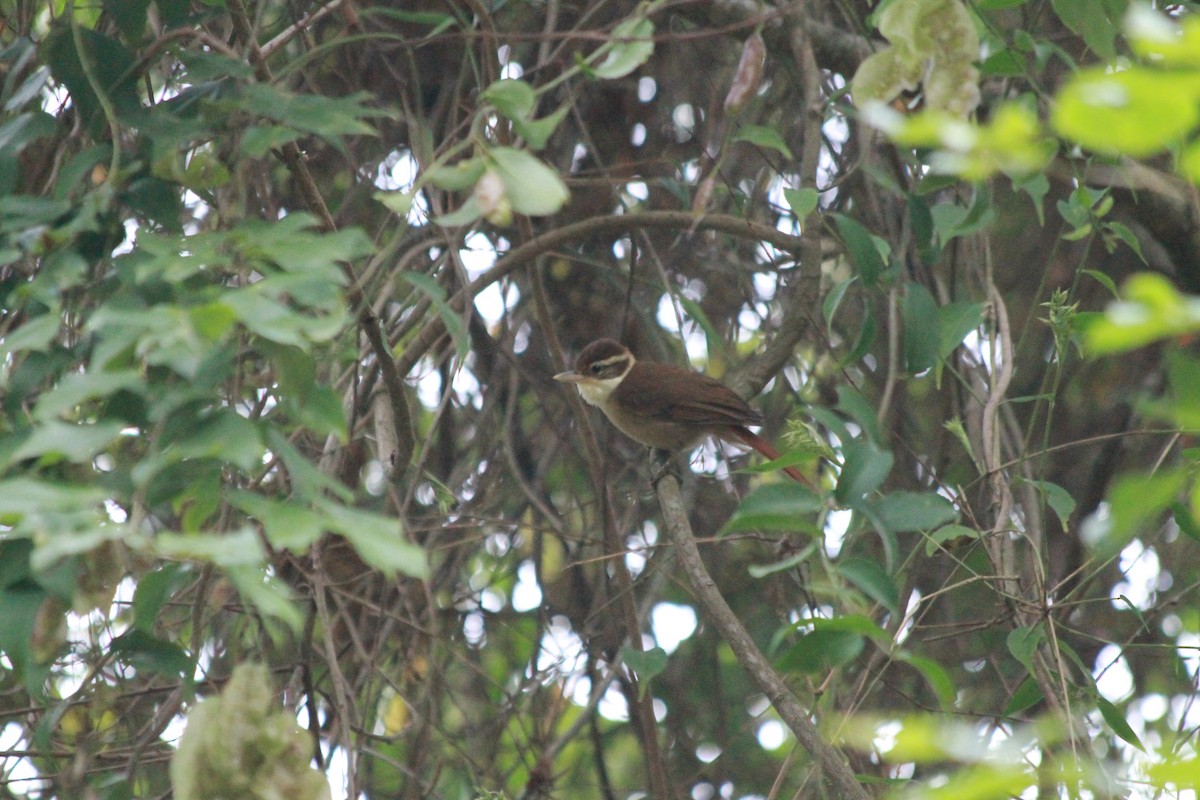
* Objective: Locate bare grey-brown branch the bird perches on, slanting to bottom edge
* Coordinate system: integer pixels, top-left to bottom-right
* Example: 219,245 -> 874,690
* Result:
655,474 -> 871,800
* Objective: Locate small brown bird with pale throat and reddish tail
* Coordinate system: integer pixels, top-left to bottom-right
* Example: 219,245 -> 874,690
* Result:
554,338 -> 809,485
